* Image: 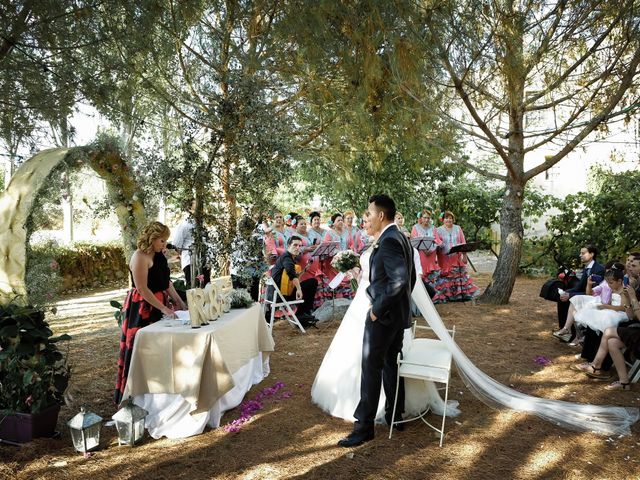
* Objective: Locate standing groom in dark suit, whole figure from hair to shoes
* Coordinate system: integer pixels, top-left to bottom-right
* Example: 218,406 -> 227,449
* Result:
338,195 -> 416,447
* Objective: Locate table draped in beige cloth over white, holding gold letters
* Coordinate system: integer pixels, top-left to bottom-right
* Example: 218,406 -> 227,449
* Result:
123,304 -> 274,438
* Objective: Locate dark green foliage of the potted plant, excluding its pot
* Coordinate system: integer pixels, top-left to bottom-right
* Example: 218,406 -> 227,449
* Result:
0,303 -> 71,414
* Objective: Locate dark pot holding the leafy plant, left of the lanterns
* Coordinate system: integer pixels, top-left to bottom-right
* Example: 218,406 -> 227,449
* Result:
0,405 -> 60,443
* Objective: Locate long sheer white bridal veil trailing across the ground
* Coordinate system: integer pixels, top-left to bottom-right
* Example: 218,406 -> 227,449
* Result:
413,282 -> 639,435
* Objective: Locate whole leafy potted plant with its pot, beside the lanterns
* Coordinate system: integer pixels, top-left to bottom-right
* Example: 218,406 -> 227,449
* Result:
0,303 -> 71,443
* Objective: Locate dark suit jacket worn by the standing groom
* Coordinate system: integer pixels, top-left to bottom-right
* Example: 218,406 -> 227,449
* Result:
367,225 -> 416,328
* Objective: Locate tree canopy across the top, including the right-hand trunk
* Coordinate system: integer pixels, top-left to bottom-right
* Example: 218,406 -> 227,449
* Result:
0,0 -> 640,303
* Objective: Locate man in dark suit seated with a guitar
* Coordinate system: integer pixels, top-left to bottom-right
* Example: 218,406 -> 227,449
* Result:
268,235 -> 318,326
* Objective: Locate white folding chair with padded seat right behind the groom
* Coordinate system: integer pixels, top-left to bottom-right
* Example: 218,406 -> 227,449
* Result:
389,322 -> 456,447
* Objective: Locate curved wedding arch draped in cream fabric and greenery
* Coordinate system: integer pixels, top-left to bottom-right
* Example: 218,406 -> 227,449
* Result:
0,140 -> 146,304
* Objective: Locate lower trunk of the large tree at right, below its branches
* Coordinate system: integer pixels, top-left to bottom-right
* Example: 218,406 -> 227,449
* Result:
479,180 -> 524,305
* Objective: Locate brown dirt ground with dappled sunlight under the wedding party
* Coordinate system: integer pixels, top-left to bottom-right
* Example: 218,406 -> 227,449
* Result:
0,274 -> 640,480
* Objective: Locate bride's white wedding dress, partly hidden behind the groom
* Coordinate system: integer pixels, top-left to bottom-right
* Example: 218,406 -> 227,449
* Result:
311,250 -> 460,422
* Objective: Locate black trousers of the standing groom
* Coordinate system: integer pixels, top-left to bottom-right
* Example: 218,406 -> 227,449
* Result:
353,313 -> 404,430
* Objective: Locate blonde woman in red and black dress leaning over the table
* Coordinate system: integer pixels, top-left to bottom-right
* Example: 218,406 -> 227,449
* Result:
114,222 -> 187,404
